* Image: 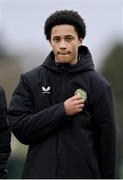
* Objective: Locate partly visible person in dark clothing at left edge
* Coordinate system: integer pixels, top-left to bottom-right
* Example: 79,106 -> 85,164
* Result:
0,87 -> 11,179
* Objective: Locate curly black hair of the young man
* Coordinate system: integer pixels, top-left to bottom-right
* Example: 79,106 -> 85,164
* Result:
44,10 -> 86,40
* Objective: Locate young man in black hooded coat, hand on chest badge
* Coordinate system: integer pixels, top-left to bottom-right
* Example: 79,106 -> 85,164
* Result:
9,10 -> 115,179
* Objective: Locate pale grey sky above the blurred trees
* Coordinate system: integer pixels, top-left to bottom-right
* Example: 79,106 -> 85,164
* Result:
0,0 -> 123,69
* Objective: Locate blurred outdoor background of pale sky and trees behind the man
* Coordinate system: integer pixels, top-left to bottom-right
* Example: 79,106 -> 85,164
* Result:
0,0 -> 123,179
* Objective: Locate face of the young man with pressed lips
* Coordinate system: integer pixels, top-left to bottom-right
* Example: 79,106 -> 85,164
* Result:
50,24 -> 82,64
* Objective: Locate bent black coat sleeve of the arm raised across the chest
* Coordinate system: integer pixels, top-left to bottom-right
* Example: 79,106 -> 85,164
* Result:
8,74 -> 67,145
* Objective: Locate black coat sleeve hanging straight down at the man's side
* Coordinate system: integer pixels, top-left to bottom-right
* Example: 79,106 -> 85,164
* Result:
92,86 -> 116,179
